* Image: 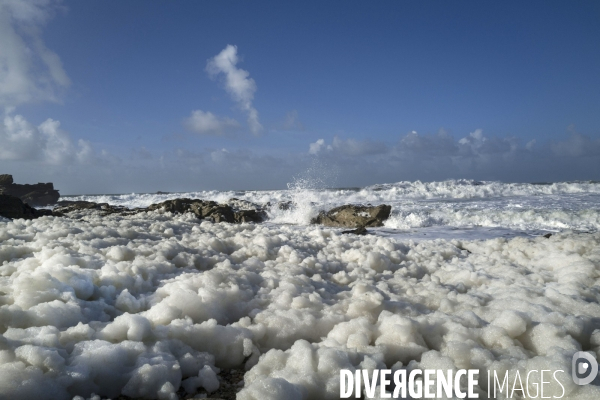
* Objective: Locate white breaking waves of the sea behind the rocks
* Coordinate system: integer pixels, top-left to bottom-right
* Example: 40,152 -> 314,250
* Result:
62,180 -> 600,231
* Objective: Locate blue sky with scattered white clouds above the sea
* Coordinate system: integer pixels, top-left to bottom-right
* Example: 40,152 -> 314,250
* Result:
0,0 -> 600,193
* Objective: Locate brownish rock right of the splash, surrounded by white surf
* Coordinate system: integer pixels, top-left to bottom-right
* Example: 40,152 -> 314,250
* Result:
311,204 -> 392,228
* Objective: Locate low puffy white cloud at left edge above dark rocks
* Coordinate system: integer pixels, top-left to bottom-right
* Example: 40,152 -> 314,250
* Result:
0,114 -> 93,165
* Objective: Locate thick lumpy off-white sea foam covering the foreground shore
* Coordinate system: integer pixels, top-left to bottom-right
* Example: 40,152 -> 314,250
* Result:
0,212 -> 600,400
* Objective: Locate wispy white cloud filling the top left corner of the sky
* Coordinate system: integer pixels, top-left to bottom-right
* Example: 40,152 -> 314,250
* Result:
0,0 -> 70,107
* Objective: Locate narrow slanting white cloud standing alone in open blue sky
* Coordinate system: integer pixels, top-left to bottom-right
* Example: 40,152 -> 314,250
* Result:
206,45 -> 263,135
